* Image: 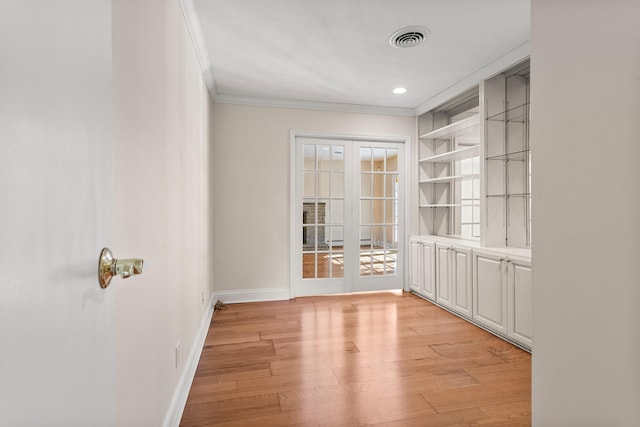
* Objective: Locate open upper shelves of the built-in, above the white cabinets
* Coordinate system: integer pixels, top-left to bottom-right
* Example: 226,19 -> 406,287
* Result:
418,61 -> 531,248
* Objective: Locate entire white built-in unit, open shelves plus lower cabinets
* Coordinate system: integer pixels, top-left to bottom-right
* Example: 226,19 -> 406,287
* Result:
409,61 -> 533,350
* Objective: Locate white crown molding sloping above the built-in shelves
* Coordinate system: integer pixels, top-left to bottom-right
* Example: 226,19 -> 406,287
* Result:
414,40 -> 531,116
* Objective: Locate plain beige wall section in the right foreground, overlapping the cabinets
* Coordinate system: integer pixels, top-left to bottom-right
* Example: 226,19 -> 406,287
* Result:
531,0 -> 640,426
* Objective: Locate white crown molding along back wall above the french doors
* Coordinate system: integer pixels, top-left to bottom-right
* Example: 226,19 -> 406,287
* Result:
215,93 -> 416,117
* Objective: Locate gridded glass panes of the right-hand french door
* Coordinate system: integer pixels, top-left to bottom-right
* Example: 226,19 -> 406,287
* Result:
359,147 -> 399,277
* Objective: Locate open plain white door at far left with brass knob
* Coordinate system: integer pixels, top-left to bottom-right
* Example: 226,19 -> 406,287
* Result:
0,0 -> 115,426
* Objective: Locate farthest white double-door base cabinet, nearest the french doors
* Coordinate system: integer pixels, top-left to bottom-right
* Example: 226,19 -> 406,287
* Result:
409,238 -> 436,301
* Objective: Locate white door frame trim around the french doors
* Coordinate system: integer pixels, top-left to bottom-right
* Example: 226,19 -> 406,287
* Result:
289,129 -> 413,298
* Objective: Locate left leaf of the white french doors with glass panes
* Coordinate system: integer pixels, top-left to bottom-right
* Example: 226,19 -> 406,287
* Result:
292,137 -> 354,295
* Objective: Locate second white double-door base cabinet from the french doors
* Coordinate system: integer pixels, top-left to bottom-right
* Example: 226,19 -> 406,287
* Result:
436,243 -> 472,317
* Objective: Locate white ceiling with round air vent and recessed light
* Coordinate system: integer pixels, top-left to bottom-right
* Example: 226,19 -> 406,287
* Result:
182,0 -> 530,115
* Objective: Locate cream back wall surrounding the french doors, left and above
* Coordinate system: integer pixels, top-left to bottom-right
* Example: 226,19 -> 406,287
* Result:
212,103 -> 416,301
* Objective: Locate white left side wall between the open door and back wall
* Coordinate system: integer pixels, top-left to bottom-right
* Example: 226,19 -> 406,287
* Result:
112,0 -> 211,426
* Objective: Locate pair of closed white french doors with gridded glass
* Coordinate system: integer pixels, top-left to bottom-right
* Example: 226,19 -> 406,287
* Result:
291,136 -> 404,296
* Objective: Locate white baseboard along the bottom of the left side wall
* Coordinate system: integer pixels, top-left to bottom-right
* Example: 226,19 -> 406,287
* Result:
162,295 -> 215,427
